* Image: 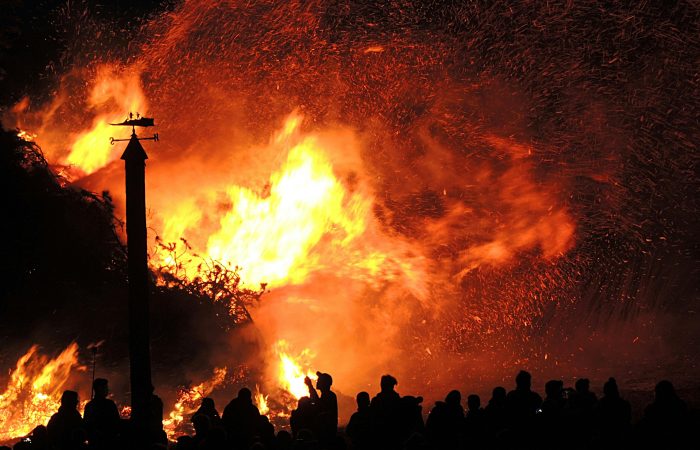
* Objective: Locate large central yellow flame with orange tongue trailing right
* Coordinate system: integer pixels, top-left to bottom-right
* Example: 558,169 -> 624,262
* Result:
155,114 -> 422,289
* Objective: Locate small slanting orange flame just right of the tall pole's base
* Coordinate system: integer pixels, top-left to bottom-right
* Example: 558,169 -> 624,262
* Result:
163,367 -> 227,440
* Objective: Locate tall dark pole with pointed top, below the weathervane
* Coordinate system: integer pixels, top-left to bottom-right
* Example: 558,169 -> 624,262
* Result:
121,131 -> 152,448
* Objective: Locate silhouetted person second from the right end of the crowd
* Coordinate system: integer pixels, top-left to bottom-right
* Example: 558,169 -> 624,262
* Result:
595,377 -> 632,448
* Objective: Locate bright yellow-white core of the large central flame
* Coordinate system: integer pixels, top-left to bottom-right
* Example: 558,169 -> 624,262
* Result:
208,138 -> 369,287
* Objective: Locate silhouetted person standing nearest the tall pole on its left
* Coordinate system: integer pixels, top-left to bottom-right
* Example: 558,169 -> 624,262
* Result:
84,378 -> 119,449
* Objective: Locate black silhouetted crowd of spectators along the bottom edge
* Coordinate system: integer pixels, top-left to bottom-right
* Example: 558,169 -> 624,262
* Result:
0,371 -> 700,450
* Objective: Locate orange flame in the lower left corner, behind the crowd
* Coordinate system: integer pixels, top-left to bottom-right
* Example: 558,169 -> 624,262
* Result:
0,342 -> 83,442
